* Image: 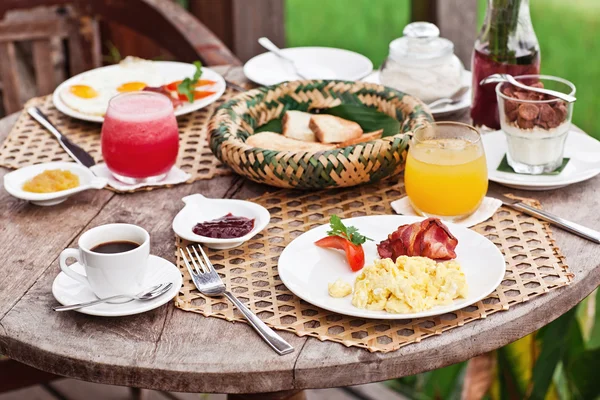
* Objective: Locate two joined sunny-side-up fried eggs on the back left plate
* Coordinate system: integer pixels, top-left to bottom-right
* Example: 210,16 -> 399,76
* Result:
59,57 -> 165,116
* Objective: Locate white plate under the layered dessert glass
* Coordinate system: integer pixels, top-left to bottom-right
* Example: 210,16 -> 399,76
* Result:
482,130 -> 600,190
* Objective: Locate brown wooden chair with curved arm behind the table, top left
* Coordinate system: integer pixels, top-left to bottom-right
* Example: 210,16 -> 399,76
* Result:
0,0 -> 240,113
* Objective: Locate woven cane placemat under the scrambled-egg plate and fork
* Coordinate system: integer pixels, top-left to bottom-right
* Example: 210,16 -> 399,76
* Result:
175,183 -> 572,352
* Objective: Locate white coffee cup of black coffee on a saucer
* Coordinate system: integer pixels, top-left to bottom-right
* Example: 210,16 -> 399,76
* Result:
59,224 -> 150,298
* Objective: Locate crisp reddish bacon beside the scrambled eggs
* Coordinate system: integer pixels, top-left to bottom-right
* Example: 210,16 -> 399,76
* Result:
377,218 -> 458,260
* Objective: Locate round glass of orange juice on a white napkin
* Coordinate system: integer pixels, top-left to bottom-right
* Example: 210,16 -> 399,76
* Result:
404,122 -> 488,221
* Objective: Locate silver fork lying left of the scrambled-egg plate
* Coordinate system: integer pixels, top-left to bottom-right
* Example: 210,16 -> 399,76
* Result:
179,245 -> 294,355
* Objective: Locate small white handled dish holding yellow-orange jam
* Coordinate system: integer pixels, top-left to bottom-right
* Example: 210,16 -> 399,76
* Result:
4,161 -> 107,206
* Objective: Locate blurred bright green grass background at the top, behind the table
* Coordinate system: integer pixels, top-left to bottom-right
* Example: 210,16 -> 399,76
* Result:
285,0 -> 600,139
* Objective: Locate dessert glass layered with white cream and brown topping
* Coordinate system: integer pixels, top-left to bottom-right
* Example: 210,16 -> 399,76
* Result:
496,75 -> 575,175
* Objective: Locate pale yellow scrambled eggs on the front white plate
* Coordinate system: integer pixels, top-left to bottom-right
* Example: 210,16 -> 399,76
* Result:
352,256 -> 468,313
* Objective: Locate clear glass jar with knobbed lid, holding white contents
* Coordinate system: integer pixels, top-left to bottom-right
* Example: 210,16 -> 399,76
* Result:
380,22 -> 464,103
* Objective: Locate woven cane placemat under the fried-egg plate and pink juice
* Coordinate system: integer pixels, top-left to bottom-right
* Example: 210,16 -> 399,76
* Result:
0,90 -> 235,191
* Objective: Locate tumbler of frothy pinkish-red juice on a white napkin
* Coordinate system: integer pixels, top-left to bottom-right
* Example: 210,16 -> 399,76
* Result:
102,92 -> 179,184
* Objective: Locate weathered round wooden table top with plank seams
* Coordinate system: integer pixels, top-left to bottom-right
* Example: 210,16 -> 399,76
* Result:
0,67 -> 600,393
